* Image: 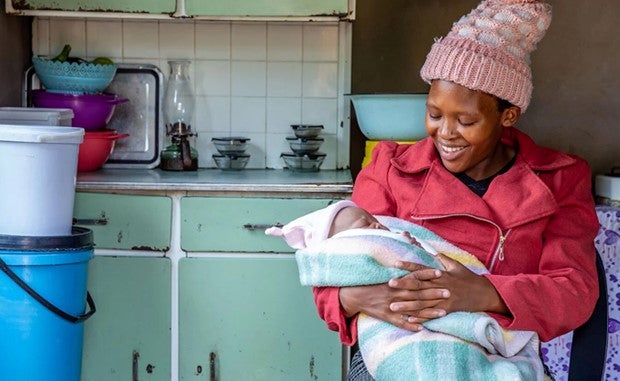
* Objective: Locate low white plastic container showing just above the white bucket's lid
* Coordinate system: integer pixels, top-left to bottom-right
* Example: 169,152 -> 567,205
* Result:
0,107 -> 73,127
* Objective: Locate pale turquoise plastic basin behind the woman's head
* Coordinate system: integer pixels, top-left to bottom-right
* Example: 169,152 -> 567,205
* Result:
350,94 -> 428,141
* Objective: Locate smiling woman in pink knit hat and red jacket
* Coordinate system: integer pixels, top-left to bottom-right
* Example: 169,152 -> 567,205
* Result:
314,0 -> 598,379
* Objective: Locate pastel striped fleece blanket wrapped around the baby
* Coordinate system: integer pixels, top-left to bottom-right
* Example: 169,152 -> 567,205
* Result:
295,216 -> 544,381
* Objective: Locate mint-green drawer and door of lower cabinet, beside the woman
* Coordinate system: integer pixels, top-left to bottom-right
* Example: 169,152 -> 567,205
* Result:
179,196 -> 342,381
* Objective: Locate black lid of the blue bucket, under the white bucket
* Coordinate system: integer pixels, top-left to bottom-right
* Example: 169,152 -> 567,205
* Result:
0,227 -> 94,251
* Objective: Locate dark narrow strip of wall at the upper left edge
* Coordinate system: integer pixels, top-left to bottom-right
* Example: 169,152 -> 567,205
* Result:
0,0 -> 32,107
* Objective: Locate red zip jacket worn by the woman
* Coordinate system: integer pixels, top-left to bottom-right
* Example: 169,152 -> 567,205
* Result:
314,128 -> 598,345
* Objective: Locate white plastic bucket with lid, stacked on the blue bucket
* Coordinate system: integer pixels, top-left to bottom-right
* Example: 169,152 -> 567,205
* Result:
0,124 -> 84,236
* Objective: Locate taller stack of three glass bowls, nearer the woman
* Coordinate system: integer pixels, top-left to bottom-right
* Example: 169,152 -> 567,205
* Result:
280,124 -> 326,172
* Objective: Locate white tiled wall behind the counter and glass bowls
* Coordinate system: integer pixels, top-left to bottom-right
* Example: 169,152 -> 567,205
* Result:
33,18 -> 351,169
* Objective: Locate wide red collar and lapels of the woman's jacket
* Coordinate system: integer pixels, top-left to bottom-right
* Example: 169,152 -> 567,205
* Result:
392,128 -> 575,228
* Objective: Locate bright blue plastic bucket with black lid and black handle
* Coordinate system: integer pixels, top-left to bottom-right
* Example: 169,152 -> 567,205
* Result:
0,228 -> 95,381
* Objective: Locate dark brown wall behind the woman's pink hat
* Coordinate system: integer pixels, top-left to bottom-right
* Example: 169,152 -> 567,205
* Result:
351,0 -> 620,179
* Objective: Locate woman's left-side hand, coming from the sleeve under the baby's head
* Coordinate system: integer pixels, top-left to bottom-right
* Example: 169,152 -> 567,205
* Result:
339,263 -> 446,331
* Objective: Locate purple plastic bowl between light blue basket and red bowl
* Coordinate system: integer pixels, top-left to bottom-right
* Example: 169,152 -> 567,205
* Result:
32,90 -> 127,131
